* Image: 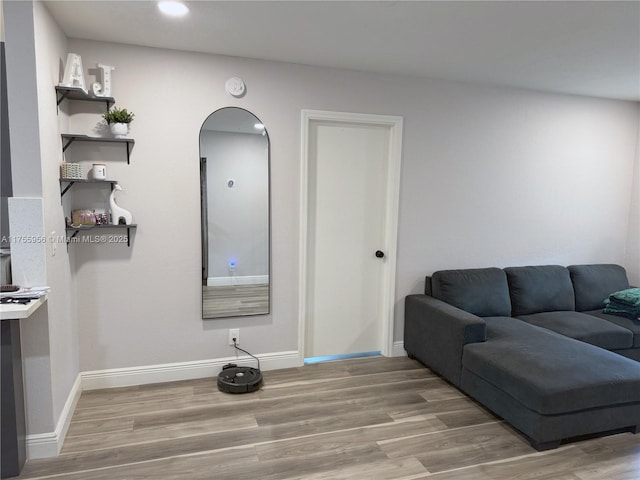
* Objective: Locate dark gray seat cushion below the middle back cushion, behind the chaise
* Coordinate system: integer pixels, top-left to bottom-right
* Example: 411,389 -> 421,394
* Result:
517,312 -> 633,350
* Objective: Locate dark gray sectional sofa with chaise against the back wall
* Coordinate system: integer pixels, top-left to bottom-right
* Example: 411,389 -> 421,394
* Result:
404,264 -> 640,450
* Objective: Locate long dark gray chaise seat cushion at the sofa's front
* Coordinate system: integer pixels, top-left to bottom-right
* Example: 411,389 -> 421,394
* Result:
462,317 -> 640,415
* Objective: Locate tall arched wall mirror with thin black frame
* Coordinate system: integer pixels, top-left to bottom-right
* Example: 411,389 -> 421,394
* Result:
200,107 -> 270,318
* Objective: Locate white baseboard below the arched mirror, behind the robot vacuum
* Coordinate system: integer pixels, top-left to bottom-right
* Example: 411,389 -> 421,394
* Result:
80,351 -> 299,390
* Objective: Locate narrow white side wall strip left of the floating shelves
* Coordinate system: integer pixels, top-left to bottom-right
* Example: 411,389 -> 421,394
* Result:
34,2 -> 80,436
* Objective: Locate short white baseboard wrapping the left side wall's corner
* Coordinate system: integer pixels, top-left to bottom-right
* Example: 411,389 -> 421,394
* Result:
26,374 -> 82,460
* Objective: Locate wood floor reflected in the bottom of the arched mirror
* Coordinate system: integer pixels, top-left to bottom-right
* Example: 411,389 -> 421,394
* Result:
202,283 -> 269,318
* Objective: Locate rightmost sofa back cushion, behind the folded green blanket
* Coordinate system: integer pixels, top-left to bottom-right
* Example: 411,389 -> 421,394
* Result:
567,264 -> 629,312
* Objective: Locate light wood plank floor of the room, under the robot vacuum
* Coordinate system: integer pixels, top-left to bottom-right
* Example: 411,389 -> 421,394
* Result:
16,357 -> 640,480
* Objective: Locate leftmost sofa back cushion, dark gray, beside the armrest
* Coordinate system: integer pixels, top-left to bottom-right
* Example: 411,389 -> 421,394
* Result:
431,268 -> 511,317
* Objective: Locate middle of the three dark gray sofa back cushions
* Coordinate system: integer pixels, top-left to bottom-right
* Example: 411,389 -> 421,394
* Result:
504,265 -> 575,317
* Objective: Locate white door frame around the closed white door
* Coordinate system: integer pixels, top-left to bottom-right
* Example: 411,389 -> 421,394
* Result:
298,109 -> 402,365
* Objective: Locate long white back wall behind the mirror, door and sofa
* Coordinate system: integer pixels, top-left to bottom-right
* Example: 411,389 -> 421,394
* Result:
58,40 -> 639,370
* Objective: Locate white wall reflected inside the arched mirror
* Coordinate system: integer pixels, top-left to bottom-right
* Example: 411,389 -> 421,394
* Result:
200,130 -> 269,278
